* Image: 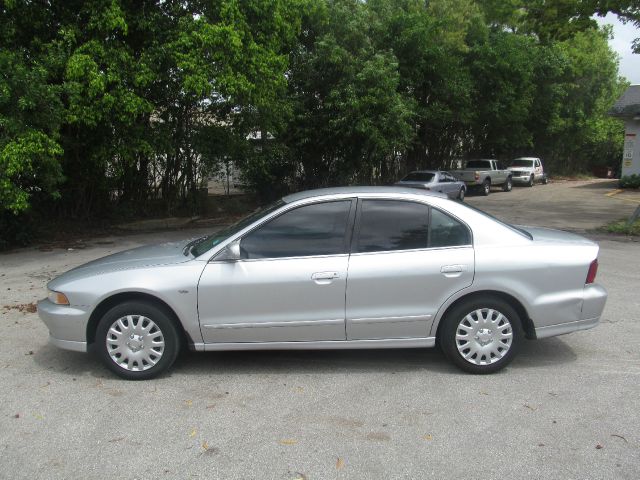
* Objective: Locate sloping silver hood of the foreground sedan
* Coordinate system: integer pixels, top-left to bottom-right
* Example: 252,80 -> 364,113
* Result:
49,240 -> 192,289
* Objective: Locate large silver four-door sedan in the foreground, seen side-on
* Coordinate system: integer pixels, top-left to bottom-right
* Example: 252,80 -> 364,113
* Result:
38,187 -> 607,379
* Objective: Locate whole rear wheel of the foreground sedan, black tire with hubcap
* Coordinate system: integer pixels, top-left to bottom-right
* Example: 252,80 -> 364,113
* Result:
438,296 -> 524,374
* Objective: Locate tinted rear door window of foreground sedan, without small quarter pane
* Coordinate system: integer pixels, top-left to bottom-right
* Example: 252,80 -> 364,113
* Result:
355,200 -> 429,252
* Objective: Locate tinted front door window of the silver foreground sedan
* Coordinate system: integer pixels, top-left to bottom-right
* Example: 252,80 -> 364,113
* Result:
240,201 -> 351,258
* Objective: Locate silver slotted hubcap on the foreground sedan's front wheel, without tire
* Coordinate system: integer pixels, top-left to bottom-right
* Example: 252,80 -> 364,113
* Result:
106,315 -> 165,372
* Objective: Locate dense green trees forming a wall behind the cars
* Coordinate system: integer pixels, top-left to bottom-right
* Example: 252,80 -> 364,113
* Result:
0,0 -> 640,246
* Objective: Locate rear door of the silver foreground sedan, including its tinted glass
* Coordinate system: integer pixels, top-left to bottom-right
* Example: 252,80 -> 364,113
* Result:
346,199 -> 474,340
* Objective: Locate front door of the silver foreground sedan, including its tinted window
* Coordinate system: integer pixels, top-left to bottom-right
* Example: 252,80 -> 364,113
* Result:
198,199 -> 355,343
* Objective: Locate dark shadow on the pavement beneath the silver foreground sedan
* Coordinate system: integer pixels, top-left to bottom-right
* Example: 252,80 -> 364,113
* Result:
33,338 -> 577,377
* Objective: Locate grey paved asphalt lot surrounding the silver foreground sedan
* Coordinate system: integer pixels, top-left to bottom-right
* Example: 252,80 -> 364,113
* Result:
0,182 -> 640,480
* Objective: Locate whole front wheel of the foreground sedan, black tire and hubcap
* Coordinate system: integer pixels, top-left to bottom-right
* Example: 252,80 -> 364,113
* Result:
94,301 -> 181,380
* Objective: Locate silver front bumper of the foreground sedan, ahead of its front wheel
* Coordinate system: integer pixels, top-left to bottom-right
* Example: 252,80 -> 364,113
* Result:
38,298 -> 90,352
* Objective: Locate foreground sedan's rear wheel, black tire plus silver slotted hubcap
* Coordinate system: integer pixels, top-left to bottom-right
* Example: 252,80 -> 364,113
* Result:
439,297 -> 524,374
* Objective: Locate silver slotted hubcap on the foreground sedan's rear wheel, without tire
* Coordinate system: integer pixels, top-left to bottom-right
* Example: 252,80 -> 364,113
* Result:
456,308 -> 513,365
